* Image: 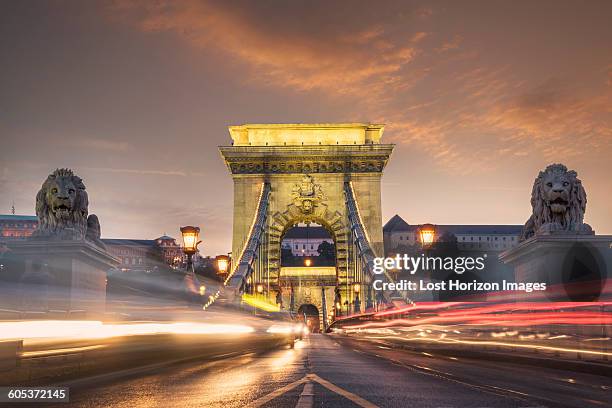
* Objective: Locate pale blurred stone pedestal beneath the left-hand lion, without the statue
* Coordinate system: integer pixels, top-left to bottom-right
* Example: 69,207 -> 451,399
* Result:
7,240 -> 119,318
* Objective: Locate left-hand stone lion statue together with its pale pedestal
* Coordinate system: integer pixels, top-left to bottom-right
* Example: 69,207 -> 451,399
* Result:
6,169 -> 119,318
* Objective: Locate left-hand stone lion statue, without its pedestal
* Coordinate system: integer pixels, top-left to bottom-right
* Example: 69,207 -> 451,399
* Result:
32,169 -> 103,246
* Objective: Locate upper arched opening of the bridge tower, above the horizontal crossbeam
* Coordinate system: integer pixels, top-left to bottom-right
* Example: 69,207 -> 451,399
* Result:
281,223 -> 336,267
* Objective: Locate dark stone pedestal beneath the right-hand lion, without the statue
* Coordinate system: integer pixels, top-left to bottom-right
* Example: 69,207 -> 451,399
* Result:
500,233 -> 612,302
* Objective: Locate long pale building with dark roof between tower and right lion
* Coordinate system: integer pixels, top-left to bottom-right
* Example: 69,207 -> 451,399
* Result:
383,215 -> 523,253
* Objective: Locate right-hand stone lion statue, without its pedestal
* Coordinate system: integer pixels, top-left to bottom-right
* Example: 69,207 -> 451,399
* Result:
520,164 -> 593,241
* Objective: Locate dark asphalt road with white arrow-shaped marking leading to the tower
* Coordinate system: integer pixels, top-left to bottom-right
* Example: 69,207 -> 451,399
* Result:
43,335 -> 612,408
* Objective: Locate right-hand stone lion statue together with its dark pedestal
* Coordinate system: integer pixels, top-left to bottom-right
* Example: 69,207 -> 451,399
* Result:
500,164 -> 612,302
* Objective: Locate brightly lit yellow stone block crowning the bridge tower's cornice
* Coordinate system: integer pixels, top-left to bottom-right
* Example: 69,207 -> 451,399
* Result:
229,123 -> 384,146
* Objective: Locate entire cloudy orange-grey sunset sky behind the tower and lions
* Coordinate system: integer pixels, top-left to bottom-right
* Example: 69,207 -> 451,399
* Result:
0,0 -> 612,255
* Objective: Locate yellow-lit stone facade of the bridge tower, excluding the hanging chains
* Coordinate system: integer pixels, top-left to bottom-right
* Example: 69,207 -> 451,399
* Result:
220,123 -> 393,320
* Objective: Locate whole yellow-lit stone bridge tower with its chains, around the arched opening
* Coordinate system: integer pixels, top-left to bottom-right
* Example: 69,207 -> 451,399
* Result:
219,123 -> 393,324
